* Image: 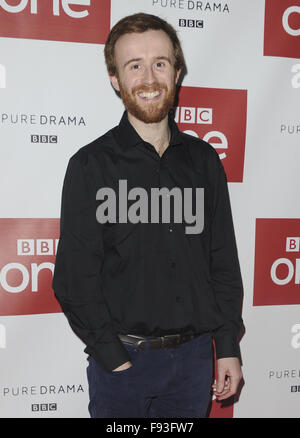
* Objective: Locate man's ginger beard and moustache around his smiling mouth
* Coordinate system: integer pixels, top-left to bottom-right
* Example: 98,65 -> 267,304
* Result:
118,76 -> 176,123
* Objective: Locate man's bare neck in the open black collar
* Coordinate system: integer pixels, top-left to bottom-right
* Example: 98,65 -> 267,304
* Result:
127,112 -> 170,156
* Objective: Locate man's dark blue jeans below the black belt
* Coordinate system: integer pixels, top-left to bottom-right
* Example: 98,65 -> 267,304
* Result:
87,334 -> 213,418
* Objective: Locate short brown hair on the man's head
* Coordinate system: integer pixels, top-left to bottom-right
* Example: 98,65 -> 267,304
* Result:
104,12 -> 185,76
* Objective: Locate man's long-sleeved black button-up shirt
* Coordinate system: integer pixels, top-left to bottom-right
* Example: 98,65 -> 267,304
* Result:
53,112 -> 242,370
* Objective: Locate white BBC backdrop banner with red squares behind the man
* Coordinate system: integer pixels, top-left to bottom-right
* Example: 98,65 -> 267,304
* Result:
0,0 -> 300,418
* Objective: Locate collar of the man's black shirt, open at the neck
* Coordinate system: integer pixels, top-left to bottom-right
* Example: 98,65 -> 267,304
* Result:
115,111 -> 182,149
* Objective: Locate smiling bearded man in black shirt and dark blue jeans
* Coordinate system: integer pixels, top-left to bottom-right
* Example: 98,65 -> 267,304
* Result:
53,13 -> 242,418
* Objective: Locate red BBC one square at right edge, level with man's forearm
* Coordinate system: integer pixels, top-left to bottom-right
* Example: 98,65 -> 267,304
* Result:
253,219 -> 300,306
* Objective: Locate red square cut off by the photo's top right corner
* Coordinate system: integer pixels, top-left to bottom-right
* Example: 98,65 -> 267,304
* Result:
264,0 -> 300,58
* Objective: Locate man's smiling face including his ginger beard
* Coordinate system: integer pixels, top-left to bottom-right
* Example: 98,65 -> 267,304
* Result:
111,30 -> 180,123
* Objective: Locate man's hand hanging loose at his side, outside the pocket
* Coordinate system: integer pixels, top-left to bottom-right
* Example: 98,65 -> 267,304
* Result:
213,357 -> 243,400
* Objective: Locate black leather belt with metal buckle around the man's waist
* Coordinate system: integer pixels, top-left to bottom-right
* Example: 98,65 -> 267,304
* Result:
118,334 -> 198,350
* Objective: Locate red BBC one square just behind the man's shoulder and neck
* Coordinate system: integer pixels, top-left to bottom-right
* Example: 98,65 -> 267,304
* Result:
175,87 -> 247,182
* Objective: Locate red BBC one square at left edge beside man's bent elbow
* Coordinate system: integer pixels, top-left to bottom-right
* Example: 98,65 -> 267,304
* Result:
0,219 -> 61,316
